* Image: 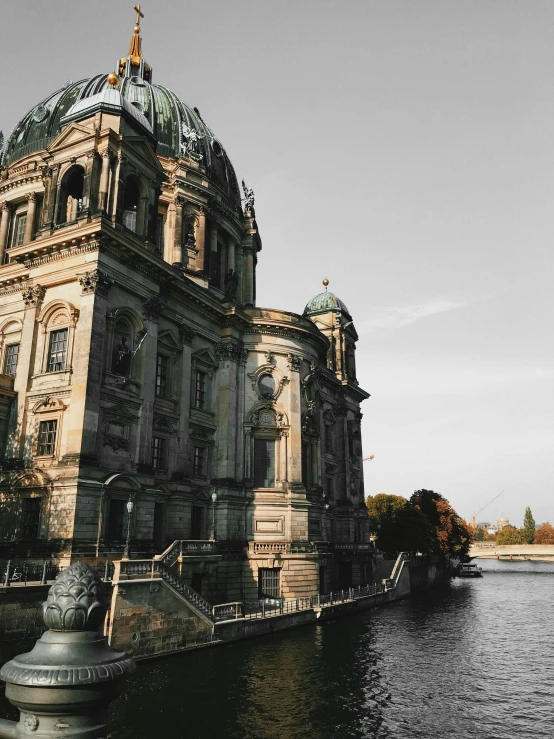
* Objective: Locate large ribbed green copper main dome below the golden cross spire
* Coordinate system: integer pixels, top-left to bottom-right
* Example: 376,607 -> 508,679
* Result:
0,74 -> 240,205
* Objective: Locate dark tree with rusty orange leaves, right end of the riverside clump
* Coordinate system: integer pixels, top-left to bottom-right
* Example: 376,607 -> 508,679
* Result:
410,490 -> 471,558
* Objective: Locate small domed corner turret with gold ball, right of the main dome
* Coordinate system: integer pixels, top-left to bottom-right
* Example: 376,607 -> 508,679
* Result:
303,279 -> 358,384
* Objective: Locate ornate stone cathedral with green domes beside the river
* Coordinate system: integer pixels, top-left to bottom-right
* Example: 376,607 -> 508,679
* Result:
0,11 -> 372,602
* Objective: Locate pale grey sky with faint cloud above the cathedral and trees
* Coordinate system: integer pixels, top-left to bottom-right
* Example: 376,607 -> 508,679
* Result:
0,0 -> 554,525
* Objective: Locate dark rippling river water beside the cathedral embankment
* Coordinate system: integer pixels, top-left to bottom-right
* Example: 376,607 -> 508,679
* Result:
0,561 -> 554,739
